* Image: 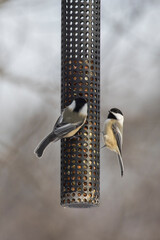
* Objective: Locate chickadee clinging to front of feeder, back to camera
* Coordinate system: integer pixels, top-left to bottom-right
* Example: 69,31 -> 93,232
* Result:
35,98 -> 87,157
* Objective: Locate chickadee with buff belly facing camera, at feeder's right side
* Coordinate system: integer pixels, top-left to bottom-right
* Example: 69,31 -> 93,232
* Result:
103,108 -> 124,176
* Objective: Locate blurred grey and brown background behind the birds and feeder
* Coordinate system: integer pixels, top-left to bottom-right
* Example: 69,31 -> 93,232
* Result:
0,0 -> 160,240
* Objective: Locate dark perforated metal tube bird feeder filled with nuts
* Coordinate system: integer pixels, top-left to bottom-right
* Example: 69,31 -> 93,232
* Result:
61,0 -> 100,208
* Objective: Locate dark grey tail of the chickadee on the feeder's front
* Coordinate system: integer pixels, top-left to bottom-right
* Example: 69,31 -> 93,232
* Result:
34,133 -> 59,158
